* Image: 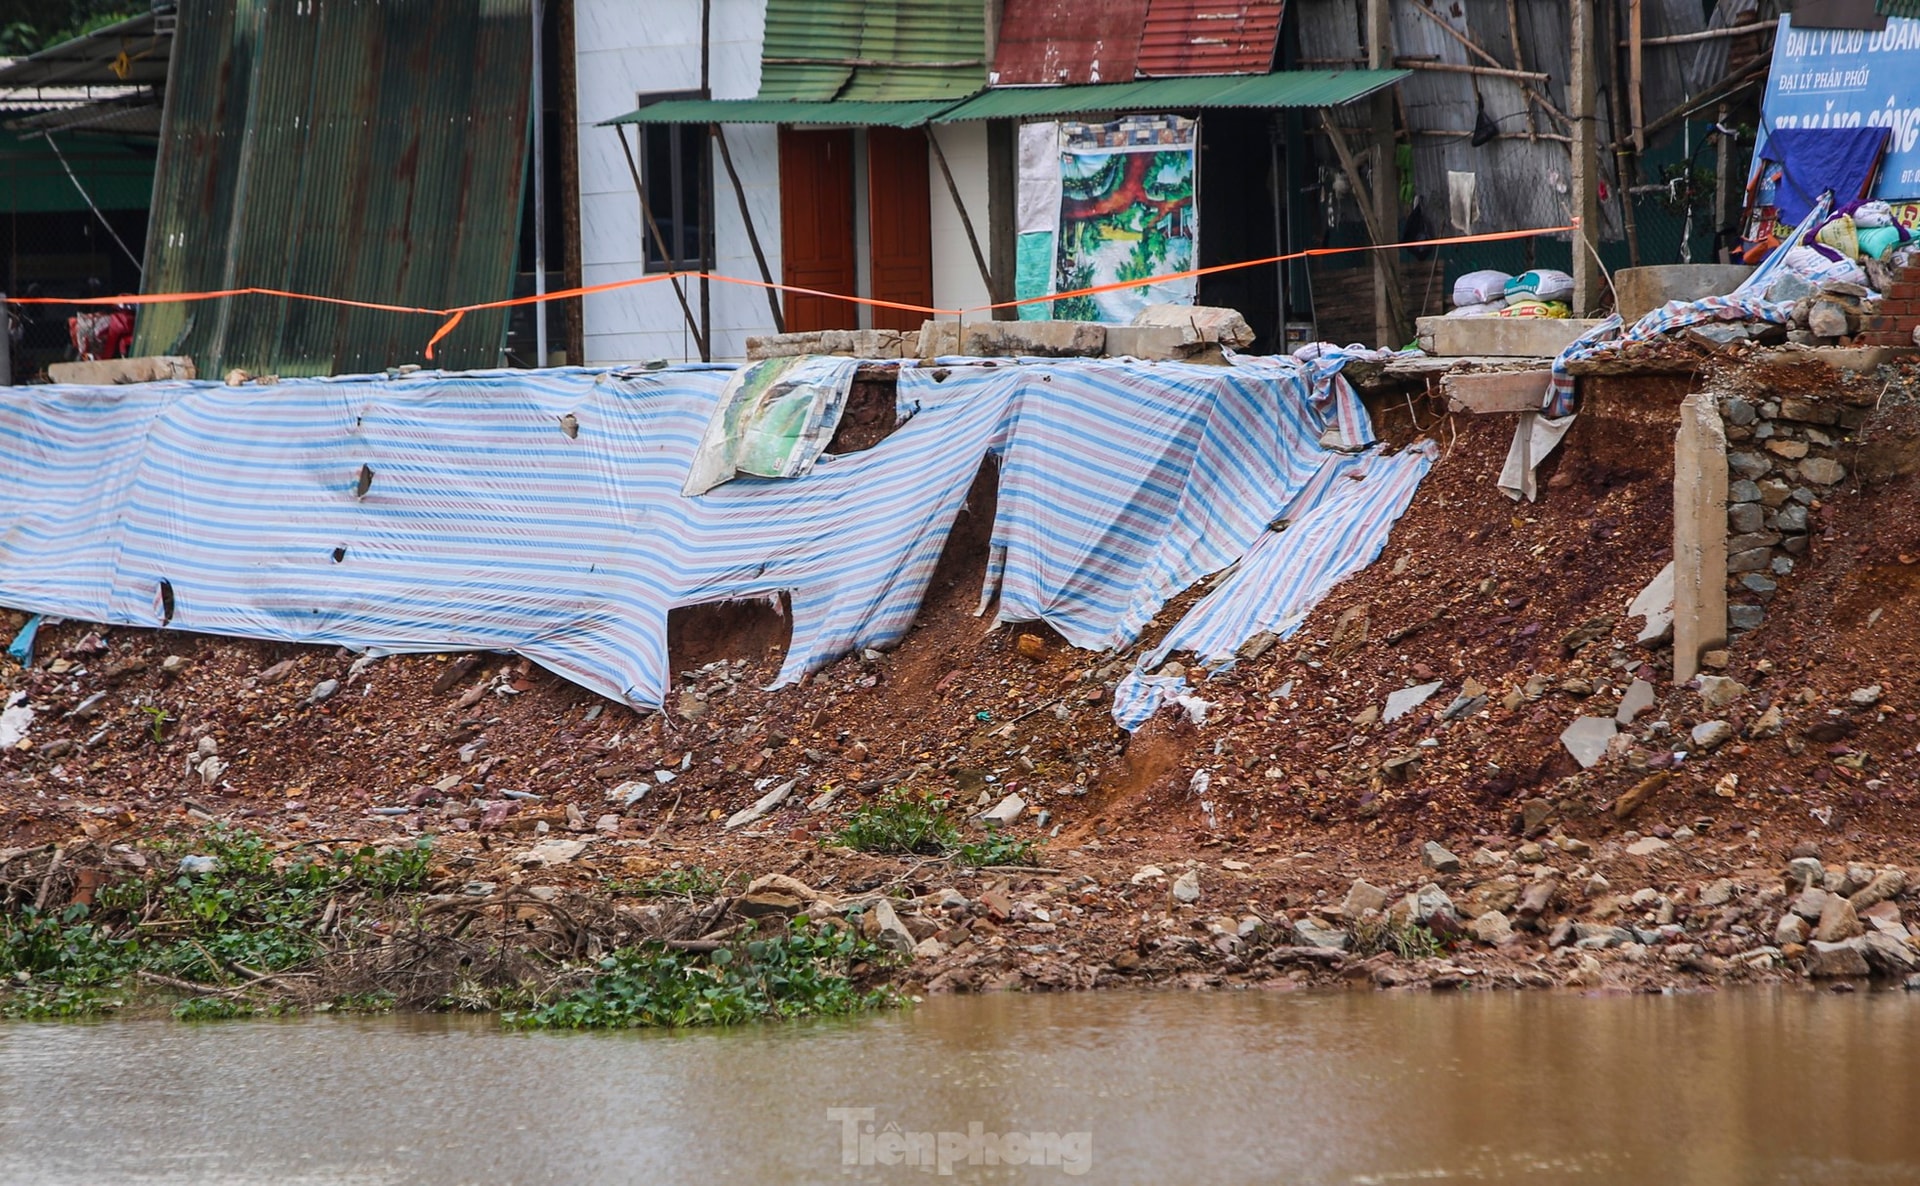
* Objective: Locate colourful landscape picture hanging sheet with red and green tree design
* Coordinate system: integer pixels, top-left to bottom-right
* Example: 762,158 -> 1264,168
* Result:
1054,115 -> 1200,324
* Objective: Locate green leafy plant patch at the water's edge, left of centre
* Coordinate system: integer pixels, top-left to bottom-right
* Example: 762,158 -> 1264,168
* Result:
503,917 -> 900,1029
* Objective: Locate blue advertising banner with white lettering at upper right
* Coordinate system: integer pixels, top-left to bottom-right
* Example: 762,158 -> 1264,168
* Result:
1753,15 -> 1920,202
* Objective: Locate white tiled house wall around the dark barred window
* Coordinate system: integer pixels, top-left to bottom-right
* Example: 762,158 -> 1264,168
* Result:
574,0 -> 780,365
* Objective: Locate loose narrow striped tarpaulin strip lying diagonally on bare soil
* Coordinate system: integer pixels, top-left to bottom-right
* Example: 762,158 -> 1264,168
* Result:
1114,441 -> 1438,731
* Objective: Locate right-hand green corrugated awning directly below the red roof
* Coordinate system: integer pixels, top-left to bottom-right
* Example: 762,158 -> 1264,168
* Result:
933,69 -> 1413,123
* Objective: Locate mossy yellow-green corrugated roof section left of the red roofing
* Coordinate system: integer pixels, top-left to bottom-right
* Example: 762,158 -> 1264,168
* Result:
758,0 -> 987,102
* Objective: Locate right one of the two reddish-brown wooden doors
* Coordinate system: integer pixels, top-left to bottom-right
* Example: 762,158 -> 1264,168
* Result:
866,129 -> 933,330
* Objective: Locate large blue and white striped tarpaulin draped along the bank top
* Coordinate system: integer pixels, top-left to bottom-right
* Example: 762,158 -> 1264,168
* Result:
0,361 -> 1390,706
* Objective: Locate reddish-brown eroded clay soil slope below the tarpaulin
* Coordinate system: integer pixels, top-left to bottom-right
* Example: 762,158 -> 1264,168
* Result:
11,366 -> 1920,984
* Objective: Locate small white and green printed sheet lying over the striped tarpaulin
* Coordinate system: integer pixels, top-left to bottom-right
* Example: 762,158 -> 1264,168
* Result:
680,355 -> 860,497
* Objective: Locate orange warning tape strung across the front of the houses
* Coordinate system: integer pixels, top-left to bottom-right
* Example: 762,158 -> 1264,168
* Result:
0,223 -> 1578,361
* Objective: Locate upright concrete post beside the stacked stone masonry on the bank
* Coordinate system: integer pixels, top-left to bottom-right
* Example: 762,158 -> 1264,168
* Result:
1674,391 -> 1726,683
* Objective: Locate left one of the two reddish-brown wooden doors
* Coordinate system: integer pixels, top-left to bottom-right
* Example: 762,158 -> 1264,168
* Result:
780,127 -> 860,334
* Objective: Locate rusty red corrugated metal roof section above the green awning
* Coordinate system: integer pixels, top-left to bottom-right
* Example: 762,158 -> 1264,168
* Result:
993,0 -> 1146,86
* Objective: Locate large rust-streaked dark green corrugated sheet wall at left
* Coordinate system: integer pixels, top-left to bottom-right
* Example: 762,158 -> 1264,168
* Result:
134,0 -> 532,374
